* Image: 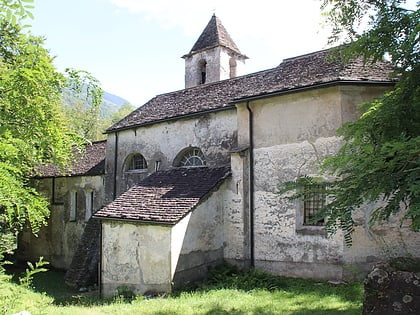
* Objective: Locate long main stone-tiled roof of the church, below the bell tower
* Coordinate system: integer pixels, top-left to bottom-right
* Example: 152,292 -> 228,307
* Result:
107,50 -> 393,133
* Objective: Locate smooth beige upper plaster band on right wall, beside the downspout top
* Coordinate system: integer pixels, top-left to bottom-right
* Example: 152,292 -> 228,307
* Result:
251,88 -> 342,148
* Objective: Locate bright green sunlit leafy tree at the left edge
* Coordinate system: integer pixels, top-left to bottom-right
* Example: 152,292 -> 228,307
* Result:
0,0 -> 102,254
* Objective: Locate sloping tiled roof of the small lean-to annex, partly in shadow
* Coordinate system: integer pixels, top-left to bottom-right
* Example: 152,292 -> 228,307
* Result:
94,167 -> 230,224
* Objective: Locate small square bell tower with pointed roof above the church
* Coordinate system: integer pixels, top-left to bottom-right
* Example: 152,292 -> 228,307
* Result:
182,14 -> 248,88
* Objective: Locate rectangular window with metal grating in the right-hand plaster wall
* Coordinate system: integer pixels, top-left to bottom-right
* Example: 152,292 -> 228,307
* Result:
303,183 -> 327,225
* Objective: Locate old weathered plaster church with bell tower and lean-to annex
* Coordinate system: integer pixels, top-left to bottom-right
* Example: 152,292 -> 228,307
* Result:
20,15 -> 420,296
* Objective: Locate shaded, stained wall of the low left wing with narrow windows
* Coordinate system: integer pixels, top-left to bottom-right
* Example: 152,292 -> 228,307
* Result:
17,176 -> 104,269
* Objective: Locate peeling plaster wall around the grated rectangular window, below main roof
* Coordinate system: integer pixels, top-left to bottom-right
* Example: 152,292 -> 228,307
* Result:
231,86 -> 412,279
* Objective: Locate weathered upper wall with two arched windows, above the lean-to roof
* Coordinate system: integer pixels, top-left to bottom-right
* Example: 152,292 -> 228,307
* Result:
106,110 -> 236,202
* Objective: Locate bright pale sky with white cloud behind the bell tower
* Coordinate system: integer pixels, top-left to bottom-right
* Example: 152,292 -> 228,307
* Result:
27,0 -> 416,106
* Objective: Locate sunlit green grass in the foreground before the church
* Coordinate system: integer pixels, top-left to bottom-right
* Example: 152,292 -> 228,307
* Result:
0,267 -> 363,315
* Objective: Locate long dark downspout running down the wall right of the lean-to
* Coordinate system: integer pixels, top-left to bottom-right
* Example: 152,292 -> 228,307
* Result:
246,101 -> 255,268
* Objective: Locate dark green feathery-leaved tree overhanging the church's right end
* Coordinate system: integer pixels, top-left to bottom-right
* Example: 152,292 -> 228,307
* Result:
300,0 -> 420,243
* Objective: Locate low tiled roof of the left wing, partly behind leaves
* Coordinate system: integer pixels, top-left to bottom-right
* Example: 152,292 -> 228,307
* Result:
34,140 -> 106,178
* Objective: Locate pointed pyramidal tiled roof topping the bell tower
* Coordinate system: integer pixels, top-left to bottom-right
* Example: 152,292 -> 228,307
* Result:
186,14 -> 242,55
